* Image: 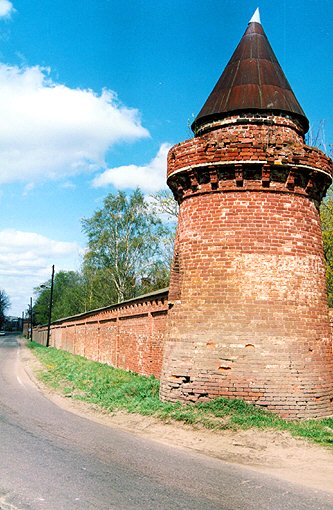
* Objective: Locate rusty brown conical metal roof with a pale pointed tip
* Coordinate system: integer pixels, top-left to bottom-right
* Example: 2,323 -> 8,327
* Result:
192,10 -> 309,132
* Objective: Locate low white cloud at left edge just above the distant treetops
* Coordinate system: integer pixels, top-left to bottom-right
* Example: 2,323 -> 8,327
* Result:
0,229 -> 82,316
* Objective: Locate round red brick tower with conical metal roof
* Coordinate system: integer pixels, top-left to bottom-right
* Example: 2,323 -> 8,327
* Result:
161,12 -> 333,418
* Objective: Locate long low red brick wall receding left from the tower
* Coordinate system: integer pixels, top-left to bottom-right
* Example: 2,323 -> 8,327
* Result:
33,289 -> 168,377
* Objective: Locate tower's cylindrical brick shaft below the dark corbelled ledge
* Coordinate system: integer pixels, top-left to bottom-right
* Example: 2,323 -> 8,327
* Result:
162,192 -> 333,416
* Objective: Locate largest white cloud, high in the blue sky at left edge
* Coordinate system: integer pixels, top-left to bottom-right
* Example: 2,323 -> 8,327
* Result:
0,63 -> 149,183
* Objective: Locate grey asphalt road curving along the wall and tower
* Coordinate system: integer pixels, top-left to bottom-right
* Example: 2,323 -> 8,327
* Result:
0,336 -> 333,510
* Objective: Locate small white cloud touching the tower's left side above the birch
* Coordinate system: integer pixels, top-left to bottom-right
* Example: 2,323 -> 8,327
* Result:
93,143 -> 171,193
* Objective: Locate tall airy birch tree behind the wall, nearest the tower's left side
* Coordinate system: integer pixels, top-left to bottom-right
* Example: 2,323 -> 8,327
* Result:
82,189 -> 172,306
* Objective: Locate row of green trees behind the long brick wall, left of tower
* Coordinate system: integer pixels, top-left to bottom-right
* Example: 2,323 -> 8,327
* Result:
33,190 -> 176,324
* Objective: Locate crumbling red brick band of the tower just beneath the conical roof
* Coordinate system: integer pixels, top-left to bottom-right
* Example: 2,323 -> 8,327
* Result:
167,114 -> 332,180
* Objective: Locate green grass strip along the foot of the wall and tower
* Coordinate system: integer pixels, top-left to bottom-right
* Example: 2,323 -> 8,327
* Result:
27,342 -> 333,447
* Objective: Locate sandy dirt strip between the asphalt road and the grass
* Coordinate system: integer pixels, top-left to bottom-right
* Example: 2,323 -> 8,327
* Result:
20,346 -> 333,494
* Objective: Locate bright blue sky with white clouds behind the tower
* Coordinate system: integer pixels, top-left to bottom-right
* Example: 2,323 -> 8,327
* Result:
0,0 -> 333,316
